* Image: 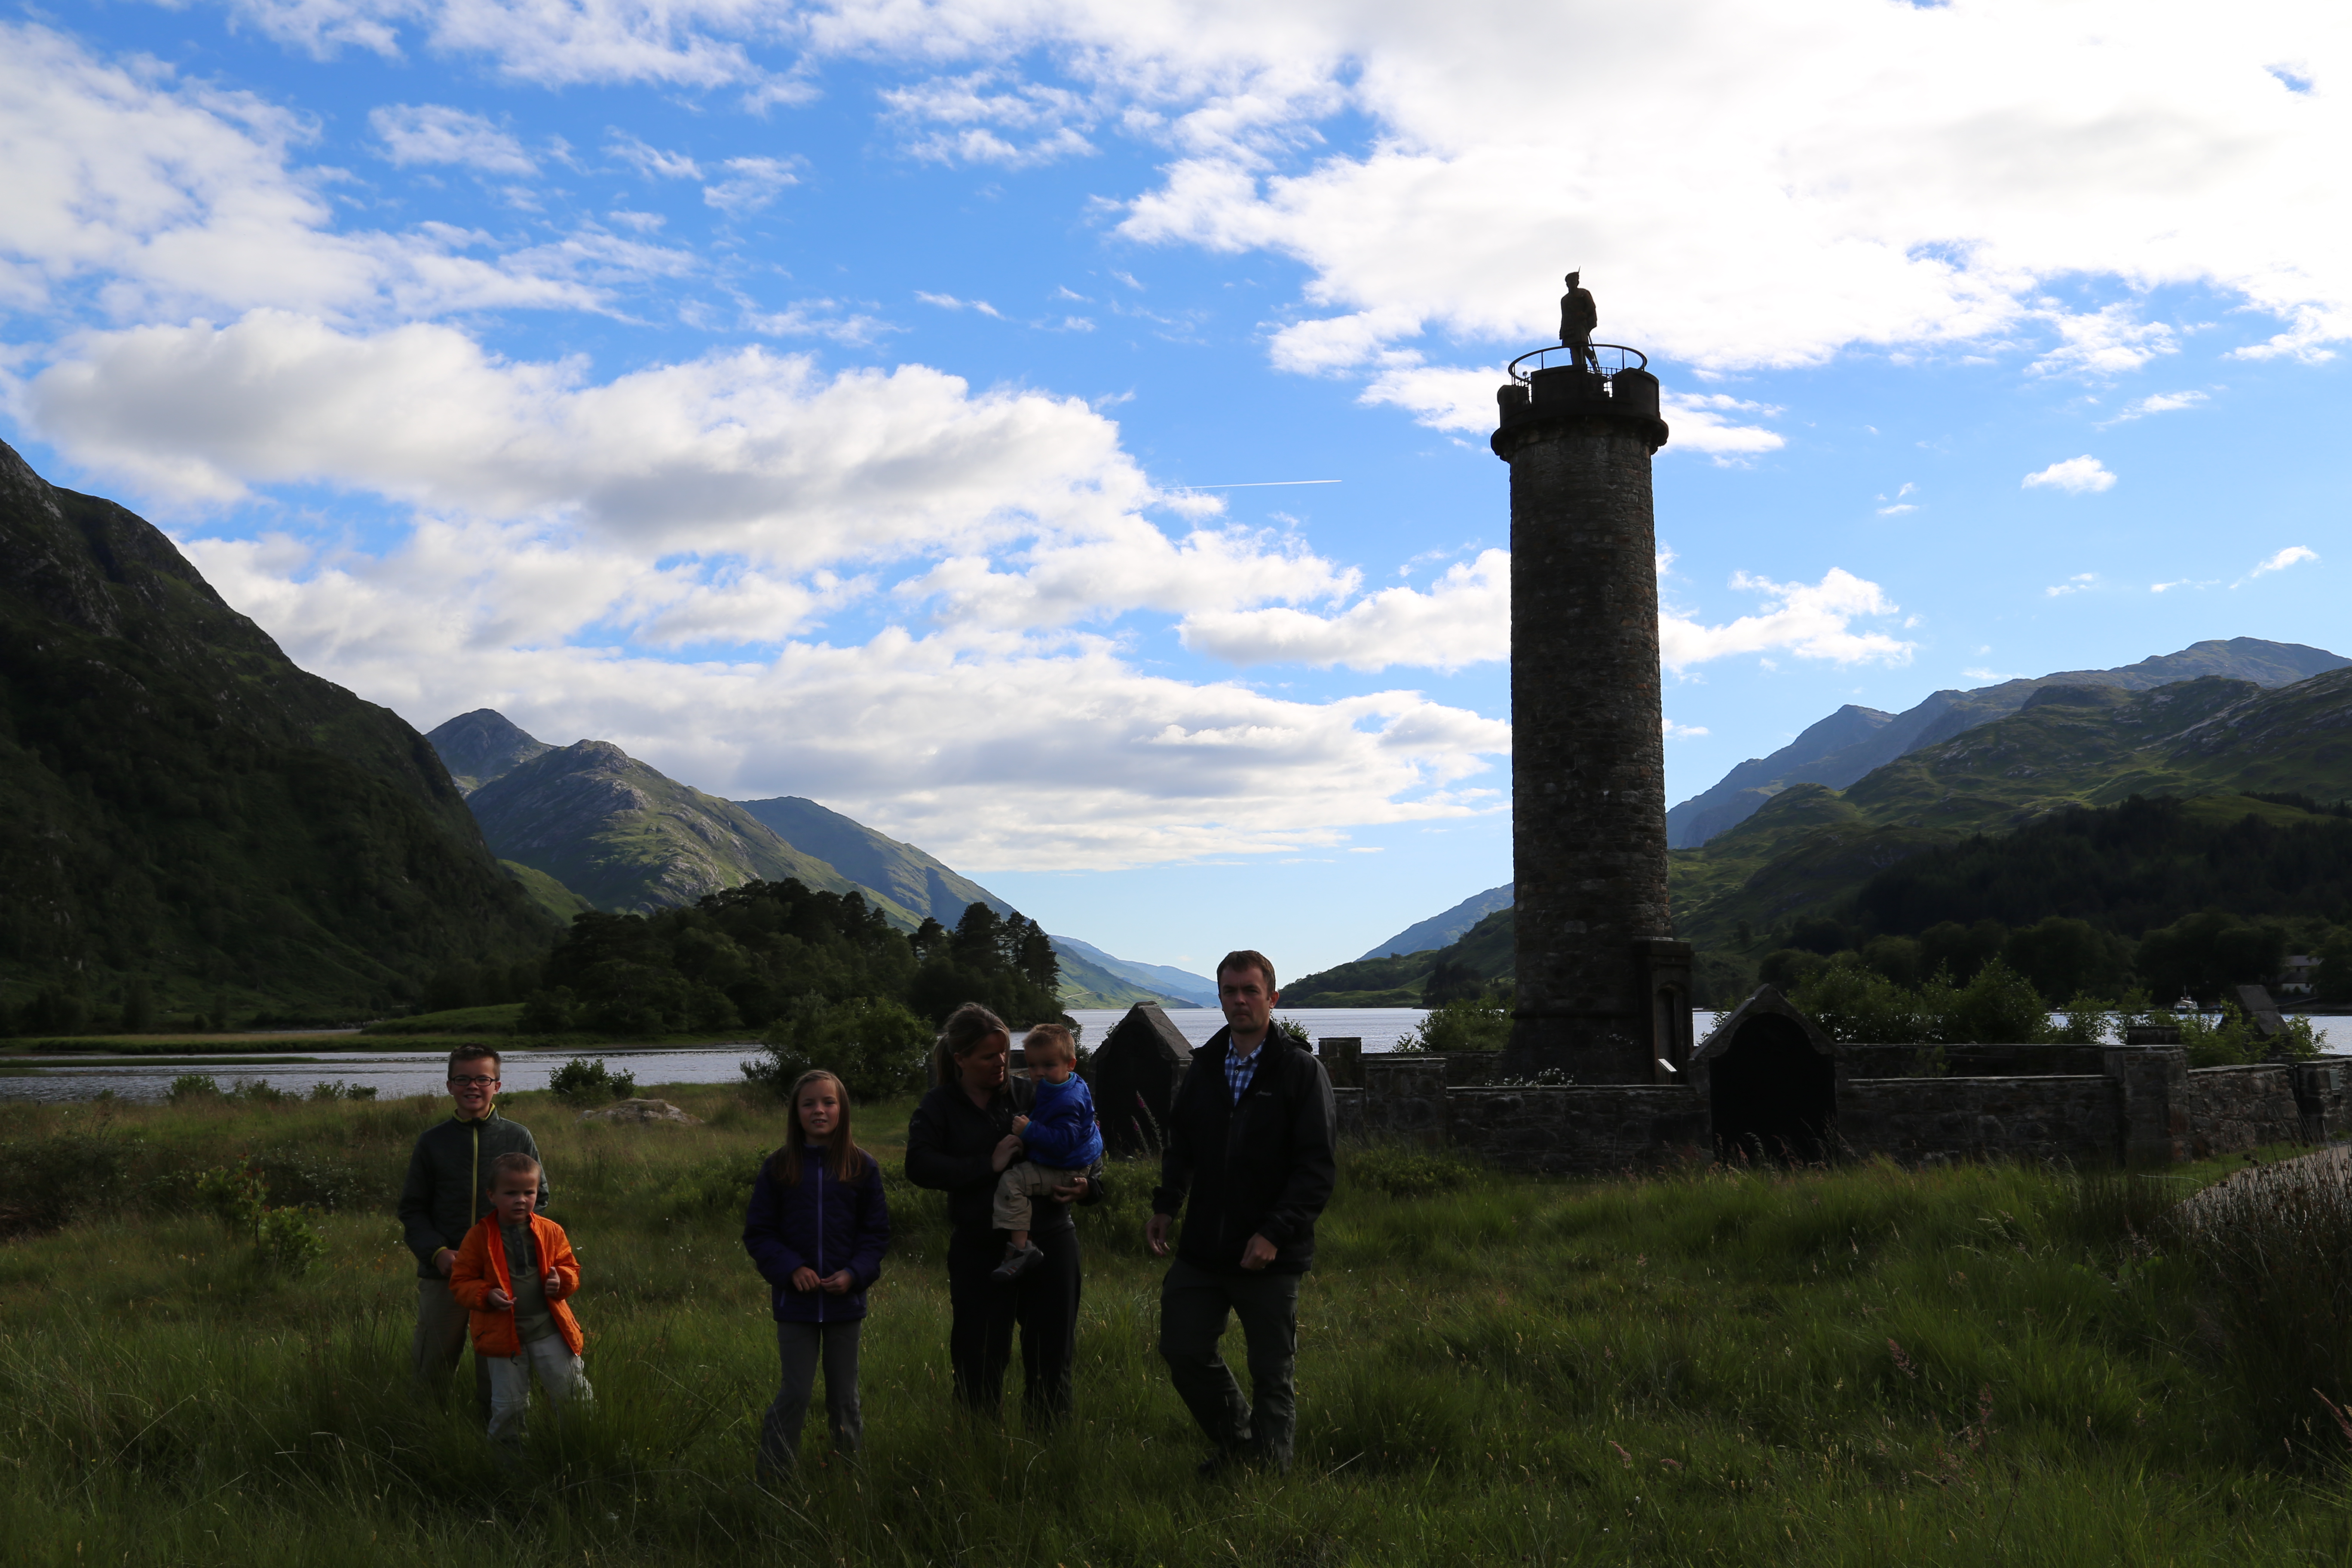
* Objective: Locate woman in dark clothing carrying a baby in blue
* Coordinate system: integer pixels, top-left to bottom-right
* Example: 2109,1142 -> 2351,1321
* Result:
906,1001 -> 1103,1420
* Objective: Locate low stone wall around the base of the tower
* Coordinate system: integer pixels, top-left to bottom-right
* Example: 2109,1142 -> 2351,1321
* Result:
1336,1046 -> 2352,1176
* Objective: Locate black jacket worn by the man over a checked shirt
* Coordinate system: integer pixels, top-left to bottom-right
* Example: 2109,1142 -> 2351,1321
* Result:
1152,1027 -> 1338,1274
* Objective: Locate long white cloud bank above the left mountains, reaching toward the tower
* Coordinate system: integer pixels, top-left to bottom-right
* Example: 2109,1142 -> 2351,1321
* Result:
184,524 -> 1510,872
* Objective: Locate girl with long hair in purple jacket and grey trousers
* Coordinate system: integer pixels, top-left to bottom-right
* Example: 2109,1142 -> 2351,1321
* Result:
743,1070 -> 889,1481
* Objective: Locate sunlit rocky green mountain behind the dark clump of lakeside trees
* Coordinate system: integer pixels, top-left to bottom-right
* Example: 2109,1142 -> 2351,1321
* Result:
466,741 -> 922,931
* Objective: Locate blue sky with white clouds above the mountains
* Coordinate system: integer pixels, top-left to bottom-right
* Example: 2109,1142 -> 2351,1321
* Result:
0,0 -> 2352,976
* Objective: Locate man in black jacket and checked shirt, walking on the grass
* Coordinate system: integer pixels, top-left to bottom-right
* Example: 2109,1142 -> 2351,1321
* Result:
1145,950 -> 1338,1476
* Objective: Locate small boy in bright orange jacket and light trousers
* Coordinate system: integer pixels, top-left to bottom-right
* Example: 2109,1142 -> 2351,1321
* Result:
449,1154 -> 593,1439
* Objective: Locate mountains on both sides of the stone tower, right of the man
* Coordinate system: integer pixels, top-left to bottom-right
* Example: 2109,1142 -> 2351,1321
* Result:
1284,637 -> 2352,1006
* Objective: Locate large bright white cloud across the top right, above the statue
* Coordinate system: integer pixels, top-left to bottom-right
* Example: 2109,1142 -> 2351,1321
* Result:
193,0 -> 2352,374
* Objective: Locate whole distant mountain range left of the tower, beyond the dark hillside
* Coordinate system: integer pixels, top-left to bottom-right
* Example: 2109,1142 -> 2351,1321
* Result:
426,707 -> 1216,1008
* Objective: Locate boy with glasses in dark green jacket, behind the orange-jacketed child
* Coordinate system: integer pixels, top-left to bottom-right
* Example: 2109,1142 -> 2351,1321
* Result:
400,1046 -> 548,1408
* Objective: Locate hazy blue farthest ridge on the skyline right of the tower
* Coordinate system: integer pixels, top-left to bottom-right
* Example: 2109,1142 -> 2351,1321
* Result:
1665,637 -> 2352,848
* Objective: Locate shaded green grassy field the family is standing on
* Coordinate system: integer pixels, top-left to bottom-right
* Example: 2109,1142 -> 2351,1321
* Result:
0,1086 -> 2352,1568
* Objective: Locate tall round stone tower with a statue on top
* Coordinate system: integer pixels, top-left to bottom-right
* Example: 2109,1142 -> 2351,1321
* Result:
1491,285 -> 1691,1084
